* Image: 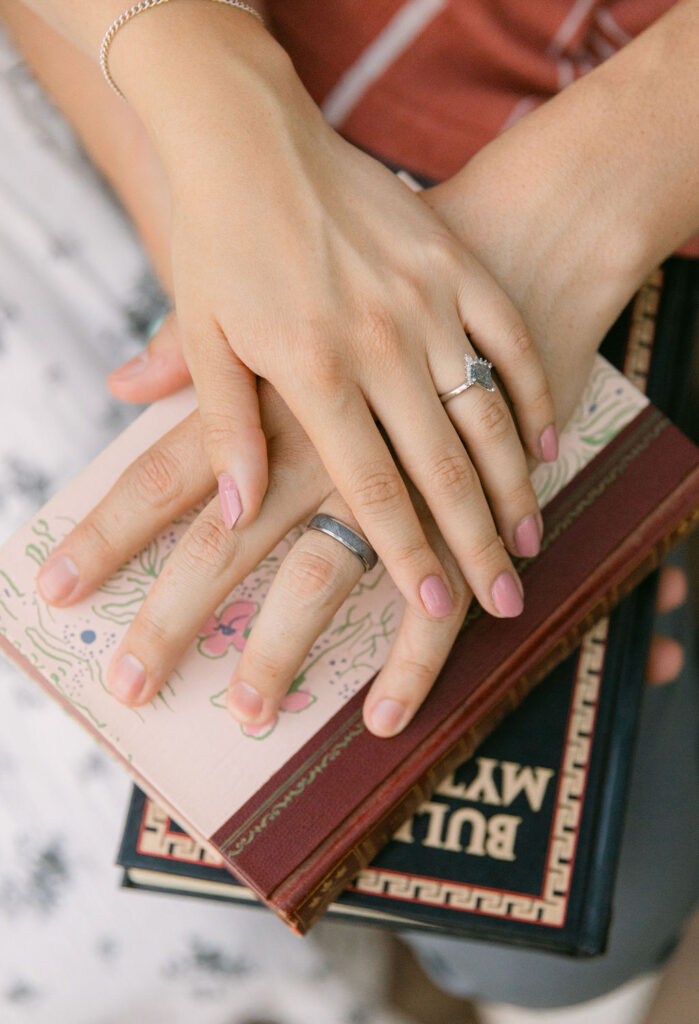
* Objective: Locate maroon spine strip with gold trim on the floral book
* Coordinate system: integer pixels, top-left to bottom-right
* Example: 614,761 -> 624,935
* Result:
211,407 -> 699,933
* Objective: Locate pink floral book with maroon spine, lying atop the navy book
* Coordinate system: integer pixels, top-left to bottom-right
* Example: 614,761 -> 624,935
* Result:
0,359 -> 699,932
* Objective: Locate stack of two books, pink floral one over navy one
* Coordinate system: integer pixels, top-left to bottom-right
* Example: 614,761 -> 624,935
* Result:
0,258 -> 699,953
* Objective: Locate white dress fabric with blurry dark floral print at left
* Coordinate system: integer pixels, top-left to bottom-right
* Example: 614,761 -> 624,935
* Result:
0,34 -> 413,1024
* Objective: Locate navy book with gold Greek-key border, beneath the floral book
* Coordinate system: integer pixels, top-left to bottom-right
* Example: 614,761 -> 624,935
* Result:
118,259 -> 699,955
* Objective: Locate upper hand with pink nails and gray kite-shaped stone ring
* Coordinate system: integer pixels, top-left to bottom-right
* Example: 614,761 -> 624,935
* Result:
102,4 -> 556,617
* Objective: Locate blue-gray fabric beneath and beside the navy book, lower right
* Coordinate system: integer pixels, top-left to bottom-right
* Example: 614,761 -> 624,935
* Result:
403,551 -> 699,1009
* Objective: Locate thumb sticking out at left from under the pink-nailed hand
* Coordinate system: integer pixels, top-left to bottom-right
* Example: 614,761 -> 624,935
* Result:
106,311 -> 191,402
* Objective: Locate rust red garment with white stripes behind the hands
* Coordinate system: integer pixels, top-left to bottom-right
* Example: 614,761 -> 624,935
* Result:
267,0 -> 699,255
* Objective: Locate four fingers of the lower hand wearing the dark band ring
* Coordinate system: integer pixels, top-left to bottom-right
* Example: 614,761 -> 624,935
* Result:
38,384 -> 471,736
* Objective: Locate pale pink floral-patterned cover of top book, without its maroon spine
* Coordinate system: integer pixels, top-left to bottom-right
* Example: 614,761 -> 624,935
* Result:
0,357 -> 695,937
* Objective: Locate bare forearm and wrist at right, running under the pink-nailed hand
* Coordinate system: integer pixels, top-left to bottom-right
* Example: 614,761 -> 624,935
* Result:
426,0 -> 699,421
